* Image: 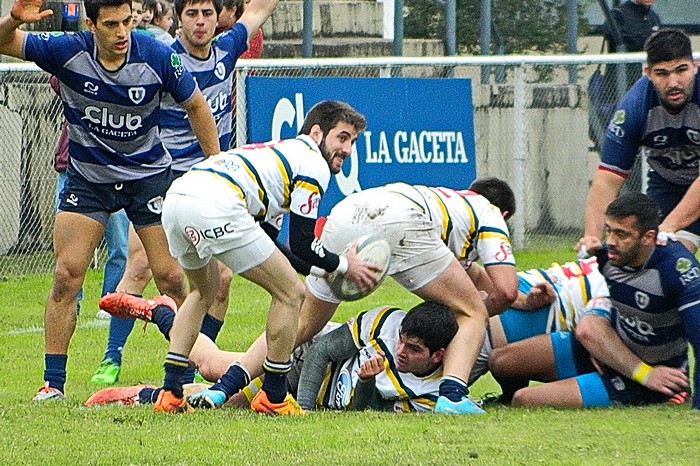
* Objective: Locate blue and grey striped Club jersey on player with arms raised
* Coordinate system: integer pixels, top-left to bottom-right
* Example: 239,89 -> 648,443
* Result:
23,31 -> 197,183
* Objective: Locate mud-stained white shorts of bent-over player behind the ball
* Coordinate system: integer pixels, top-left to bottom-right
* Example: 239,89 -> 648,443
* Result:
306,192 -> 456,303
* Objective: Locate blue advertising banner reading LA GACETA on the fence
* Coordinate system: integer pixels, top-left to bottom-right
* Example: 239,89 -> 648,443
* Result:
246,76 -> 476,238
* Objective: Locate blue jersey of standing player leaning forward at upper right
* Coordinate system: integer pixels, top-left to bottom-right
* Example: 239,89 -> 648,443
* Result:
599,74 -> 700,188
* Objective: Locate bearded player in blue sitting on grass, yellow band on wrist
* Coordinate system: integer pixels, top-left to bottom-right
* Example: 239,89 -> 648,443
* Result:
513,192 -> 700,409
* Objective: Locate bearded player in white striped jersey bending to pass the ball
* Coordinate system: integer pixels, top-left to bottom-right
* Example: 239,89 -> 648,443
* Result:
101,101 -> 380,414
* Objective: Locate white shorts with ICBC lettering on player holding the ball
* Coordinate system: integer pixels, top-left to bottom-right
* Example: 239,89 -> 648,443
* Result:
161,172 -> 275,273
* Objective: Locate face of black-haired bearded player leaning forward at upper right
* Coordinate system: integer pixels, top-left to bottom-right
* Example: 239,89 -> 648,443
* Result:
644,58 -> 698,110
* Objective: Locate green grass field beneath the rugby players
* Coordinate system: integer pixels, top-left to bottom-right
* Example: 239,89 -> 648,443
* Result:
0,250 -> 700,465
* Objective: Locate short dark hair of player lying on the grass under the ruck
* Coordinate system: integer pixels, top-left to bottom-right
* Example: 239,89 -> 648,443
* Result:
400,301 -> 458,354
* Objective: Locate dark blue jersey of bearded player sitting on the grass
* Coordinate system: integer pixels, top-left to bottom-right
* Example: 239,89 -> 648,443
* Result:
598,241 -> 700,408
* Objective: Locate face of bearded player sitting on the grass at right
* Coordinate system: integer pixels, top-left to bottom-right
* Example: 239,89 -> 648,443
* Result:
605,216 -> 649,267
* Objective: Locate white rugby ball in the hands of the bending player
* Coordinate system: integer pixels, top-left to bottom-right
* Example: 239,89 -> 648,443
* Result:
326,235 -> 391,301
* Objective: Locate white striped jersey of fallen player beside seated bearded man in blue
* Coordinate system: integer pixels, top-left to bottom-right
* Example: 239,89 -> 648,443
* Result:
518,257 -> 608,332
